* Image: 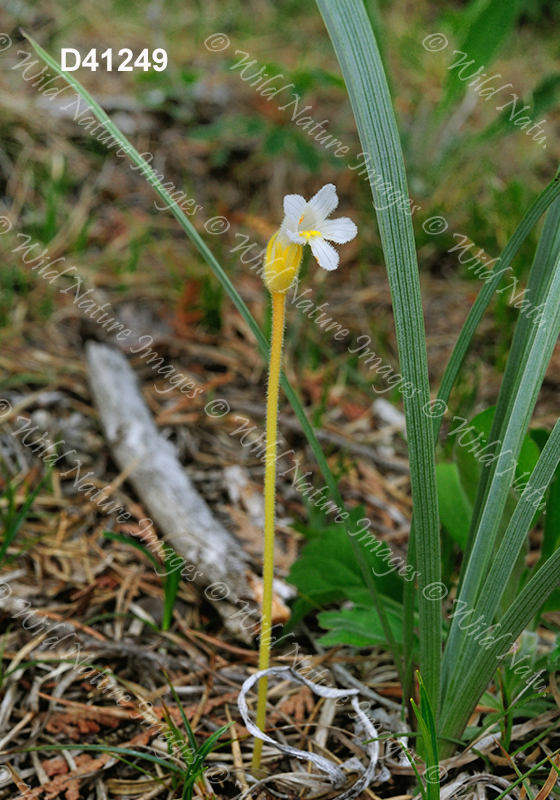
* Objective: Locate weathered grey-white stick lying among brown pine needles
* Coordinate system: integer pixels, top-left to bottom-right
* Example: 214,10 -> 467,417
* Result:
86,342 -> 274,642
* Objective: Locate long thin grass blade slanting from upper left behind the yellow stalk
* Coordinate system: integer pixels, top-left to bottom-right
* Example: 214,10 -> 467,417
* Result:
25,34 -> 402,674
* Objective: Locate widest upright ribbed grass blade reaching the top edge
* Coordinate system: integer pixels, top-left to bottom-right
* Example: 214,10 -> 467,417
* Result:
317,0 -> 441,709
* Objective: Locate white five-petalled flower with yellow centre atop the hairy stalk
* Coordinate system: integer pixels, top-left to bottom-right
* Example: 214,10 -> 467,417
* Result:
279,183 -> 358,270
